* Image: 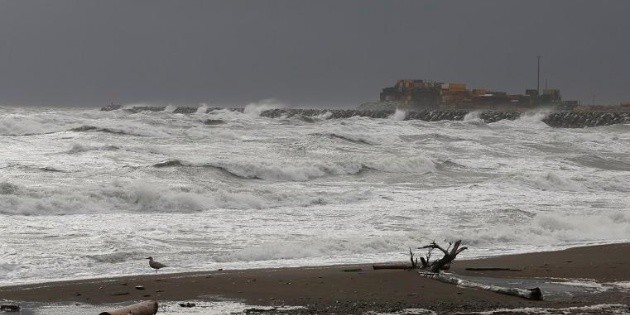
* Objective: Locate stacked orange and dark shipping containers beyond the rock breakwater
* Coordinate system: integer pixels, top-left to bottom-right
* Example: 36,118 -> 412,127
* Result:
380,79 -> 578,111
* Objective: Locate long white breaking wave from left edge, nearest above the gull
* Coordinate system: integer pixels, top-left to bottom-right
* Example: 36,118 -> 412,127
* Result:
0,182 -> 371,216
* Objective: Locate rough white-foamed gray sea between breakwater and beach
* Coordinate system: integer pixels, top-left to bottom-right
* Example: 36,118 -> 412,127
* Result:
0,105 -> 630,284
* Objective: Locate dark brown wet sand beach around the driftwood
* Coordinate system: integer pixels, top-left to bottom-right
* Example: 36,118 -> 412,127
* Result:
0,243 -> 630,314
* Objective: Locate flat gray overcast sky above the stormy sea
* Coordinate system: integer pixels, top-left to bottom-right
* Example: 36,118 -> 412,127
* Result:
0,0 -> 630,106
